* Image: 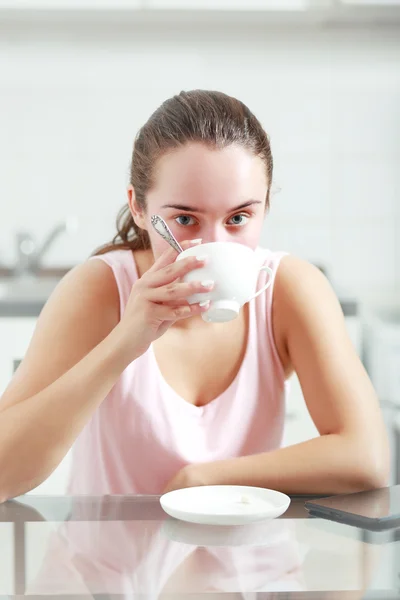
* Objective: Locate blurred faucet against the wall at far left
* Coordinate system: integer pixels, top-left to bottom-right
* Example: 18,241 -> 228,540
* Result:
12,217 -> 78,276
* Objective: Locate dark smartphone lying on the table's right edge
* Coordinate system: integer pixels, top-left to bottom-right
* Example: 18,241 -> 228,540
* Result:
305,485 -> 400,531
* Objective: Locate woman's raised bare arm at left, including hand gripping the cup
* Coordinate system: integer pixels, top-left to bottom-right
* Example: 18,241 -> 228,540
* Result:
0,244 -> 208,502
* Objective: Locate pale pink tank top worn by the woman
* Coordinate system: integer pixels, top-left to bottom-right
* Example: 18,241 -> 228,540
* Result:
68,248 -> 288,495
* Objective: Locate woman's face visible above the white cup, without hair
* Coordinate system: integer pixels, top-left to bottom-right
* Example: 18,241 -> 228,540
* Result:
131,143 -> 268,259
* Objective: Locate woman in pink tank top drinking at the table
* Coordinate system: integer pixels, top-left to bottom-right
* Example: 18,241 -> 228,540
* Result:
0,90 -> 389,500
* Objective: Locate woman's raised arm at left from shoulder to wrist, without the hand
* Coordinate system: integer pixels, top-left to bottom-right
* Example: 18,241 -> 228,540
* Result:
0,261 -> 128,502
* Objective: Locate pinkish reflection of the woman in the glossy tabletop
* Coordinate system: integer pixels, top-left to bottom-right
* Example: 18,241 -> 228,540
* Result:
25,496 -> 304,599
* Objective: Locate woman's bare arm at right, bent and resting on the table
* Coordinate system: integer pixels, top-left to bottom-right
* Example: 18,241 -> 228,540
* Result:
164,256 -> 390,494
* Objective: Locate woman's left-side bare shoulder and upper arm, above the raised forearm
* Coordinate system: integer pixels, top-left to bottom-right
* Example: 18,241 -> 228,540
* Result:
1,255 -> 119,408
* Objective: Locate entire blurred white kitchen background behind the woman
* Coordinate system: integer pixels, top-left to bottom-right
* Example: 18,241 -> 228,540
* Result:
0,0 -> 400,493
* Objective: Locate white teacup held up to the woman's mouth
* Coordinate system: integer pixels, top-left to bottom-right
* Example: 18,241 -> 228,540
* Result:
176,242 -> 272,323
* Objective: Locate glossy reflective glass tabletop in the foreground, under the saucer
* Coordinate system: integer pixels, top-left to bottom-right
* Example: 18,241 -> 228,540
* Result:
0,496 -> 400,600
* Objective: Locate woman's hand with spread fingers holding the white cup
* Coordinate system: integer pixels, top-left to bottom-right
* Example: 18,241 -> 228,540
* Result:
117,242 -> 212,358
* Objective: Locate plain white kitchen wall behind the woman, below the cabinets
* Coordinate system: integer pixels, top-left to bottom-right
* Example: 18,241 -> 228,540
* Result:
0,16 -> 400,299
